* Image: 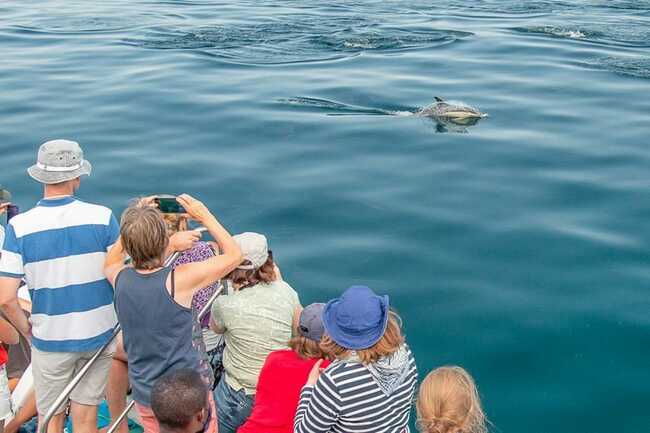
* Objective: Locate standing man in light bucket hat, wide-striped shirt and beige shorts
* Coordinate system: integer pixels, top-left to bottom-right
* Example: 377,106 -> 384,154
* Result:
0,140 -> 119,433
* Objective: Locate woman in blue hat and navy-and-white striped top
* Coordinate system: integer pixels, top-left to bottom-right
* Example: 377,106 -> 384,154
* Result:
294,286 -> 417,433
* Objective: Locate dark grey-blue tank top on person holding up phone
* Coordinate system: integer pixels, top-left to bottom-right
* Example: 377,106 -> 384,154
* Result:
115,268 -> 200,406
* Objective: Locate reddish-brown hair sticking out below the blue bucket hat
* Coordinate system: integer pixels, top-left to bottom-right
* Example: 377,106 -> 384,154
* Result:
321,311 -> 404,364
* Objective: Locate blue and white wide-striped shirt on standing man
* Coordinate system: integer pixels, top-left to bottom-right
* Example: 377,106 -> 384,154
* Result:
0,196 -> 119,352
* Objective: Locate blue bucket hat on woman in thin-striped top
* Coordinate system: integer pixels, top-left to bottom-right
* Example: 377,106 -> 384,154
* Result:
323,286 -> 388,350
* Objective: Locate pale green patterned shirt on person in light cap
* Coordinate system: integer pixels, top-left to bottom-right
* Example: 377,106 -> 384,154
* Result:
212,281 -> 300,395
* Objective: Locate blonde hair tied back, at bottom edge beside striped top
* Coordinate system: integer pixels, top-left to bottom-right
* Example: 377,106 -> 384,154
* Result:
416,366 -> 487,433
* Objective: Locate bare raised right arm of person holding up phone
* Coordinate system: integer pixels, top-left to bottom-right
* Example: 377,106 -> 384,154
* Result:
176,194 -> 243,293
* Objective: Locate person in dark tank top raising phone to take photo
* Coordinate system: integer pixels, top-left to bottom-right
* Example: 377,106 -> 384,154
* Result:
105,194 -> 242,433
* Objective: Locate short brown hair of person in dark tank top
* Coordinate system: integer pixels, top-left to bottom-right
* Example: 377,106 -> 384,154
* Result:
120,205 -> 169,269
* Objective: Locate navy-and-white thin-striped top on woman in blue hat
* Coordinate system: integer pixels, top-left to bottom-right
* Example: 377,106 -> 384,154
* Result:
294,350 -> 417,433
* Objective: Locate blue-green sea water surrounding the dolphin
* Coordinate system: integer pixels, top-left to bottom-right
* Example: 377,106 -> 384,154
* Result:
0,0 -> 650,433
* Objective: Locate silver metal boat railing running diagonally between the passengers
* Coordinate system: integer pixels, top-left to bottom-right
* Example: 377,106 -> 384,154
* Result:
39,227 -> 224,433
